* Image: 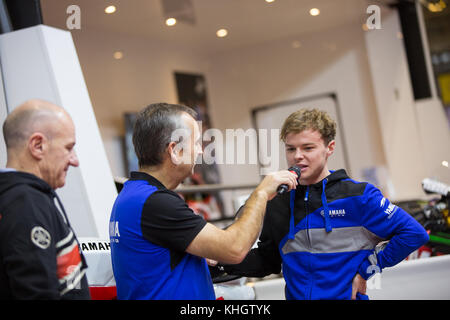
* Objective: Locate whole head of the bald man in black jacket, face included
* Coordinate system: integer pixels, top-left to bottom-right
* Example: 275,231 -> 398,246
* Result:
3,100 -> 79,189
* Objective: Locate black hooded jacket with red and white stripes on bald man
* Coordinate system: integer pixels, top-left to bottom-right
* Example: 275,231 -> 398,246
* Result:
0,171 -> 90,300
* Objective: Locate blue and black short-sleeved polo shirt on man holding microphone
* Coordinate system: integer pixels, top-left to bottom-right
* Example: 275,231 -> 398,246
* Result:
109,172 -> 215,300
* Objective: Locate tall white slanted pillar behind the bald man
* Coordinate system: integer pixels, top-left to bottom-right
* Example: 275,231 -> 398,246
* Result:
0,25 -> 117,239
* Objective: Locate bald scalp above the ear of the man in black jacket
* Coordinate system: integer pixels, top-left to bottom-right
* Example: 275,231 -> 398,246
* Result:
3,99 -> 71,150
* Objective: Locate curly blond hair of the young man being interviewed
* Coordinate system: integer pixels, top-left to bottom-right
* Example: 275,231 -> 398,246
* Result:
280,109 -> 336,145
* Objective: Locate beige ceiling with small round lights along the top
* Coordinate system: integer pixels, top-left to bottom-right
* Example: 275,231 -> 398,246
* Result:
41,0 -> 372,53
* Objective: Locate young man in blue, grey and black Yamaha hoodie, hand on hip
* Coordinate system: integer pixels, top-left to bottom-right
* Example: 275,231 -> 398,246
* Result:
225,109 -> 429,299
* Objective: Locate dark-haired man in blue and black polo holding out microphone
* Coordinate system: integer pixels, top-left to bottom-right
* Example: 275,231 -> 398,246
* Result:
110,103 -> 297,300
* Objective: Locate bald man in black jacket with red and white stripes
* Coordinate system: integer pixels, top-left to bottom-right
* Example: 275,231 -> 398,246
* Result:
0,100 -> 90,299
